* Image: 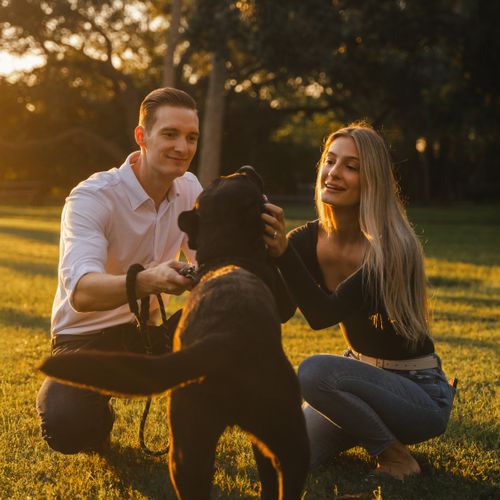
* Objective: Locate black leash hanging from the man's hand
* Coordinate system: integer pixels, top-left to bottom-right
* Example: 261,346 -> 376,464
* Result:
125,264 -> 171,457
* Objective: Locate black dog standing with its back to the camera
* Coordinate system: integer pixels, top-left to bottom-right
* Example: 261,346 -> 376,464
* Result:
41,167 -> 309,500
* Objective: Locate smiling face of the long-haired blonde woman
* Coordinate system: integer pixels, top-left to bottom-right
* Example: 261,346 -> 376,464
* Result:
320,137 -> 361,207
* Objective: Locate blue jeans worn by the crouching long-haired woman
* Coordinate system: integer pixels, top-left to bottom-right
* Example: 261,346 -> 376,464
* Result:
299,354 -> 455,467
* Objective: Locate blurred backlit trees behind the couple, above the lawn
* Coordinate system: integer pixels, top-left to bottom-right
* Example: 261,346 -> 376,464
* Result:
0,0 -> 500,203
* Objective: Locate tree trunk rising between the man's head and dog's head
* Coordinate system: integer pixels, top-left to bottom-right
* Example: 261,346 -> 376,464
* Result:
198,53 -> 226,187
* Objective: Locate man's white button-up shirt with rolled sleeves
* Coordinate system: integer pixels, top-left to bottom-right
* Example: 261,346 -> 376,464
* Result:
51,152 -> 202,335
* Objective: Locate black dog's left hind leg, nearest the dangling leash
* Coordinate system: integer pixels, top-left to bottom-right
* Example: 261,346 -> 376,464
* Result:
169,386 -> 225,500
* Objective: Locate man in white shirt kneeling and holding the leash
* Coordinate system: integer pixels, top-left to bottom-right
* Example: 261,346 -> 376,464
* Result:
37,87 -> 201,453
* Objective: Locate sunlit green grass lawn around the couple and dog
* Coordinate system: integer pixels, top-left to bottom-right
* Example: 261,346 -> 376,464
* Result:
0,206 -> 500,499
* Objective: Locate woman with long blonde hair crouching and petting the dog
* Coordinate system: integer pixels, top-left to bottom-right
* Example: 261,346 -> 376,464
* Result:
262,124 -> 454,479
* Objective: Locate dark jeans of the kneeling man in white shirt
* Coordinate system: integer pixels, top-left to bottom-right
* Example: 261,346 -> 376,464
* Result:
36,311 -> 180,454
